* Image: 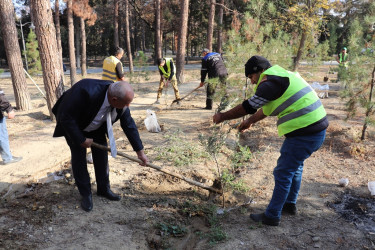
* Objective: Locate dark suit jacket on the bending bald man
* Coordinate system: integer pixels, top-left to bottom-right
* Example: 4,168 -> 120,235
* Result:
52,79 -> 143,151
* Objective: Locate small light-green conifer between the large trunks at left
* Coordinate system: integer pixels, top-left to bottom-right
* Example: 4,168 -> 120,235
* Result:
24,29 -> 42,74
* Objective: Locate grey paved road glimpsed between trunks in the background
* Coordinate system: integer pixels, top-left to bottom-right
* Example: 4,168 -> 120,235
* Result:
0,61 -> 338,78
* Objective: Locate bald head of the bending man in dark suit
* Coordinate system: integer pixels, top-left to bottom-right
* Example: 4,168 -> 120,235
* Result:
108,81 -> 134,109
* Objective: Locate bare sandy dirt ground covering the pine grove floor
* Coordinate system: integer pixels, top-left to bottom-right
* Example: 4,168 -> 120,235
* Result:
0,65 -> 375,249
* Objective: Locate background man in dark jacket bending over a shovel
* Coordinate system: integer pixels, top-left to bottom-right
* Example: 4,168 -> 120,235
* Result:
199,49 -> 228,109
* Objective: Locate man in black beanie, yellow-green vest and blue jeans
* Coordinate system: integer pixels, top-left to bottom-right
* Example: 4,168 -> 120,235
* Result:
213,56 -> 328,226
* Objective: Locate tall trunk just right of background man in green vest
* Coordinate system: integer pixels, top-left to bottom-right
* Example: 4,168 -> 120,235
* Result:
176,0 -> 189,84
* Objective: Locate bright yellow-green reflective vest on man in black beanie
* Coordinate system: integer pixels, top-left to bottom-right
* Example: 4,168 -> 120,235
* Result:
255,65 -> 326,136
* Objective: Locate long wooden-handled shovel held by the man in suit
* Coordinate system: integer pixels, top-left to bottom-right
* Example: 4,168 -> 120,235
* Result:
92,142 -> 223,194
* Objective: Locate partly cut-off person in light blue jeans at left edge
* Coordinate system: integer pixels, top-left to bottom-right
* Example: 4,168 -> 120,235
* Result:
0,89 -> 22,165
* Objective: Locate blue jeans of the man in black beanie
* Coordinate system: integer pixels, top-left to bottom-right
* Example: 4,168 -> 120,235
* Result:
265,130 -> 326,219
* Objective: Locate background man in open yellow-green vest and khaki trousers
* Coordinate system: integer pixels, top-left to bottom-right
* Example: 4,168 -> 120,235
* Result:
155,57 -> 180,104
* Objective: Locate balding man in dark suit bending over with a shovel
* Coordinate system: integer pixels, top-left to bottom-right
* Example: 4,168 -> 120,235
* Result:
52,79 -> 148,212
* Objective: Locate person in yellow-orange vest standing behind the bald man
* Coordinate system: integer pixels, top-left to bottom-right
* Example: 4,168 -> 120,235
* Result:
102,47 -> 125,82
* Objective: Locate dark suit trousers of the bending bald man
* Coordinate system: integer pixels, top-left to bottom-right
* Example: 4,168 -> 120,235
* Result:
65,129 -> 110,196
